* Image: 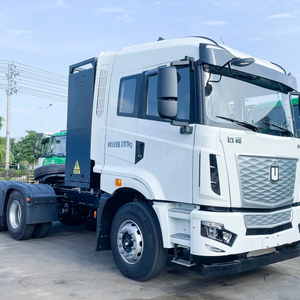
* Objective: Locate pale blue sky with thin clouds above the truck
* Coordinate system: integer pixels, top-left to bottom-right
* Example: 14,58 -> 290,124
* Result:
0,0 -> 300,139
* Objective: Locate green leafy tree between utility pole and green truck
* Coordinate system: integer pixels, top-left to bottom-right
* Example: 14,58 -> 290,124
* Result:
11,130 -> 40,164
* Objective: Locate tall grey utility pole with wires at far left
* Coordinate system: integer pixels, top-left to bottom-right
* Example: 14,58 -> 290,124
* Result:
5,63 -> 19,170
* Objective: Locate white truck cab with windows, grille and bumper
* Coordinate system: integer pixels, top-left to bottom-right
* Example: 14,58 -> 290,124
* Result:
85,38 -> 300,275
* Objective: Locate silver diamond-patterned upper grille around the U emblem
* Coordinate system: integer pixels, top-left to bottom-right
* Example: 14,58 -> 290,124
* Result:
238,155 -> 298,208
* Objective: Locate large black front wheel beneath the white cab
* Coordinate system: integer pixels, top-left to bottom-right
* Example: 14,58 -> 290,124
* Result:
111,202 -> 168,281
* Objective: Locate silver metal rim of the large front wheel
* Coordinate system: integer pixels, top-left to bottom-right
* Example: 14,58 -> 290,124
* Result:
117,220 -> 143,264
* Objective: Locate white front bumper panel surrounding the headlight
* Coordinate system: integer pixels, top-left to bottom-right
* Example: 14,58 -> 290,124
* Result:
190,206 -> 300,257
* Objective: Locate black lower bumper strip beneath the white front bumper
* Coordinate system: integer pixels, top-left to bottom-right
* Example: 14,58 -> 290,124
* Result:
201,243 -> 300,277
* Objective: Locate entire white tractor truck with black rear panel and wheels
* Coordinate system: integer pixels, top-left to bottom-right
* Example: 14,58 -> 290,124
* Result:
0,37 -> 300,281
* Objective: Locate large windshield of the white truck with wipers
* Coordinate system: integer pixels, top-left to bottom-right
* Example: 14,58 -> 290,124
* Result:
204,65 -> 294,136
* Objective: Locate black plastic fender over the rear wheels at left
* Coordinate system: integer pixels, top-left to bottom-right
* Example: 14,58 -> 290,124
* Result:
0,181 -> 58,226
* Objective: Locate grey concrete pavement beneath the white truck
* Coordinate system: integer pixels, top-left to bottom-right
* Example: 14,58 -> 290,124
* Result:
0,222 -> 300,300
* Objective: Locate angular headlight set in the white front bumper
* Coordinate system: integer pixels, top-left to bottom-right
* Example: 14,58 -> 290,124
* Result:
201,221 -> 237,246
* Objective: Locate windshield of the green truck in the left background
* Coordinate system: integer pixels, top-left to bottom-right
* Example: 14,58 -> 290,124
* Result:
42,135 -> 66,157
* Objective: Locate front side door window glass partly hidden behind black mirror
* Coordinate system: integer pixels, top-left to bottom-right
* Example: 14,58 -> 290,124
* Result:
145,67 -> 190,120
